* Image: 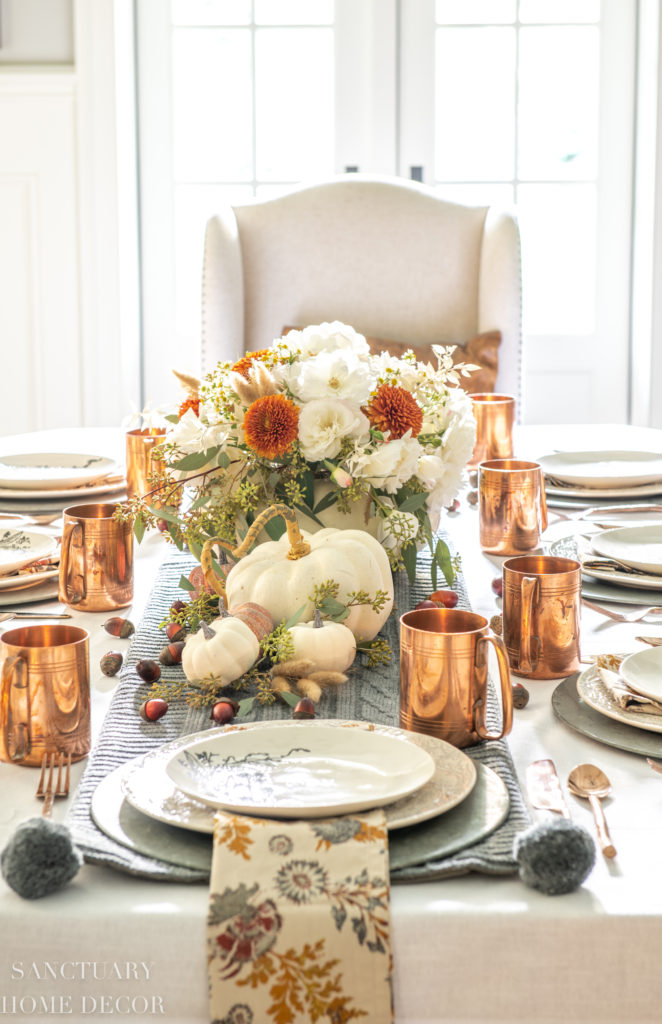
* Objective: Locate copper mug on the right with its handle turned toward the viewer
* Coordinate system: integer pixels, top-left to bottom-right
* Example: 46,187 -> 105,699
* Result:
503,555 -> 581,679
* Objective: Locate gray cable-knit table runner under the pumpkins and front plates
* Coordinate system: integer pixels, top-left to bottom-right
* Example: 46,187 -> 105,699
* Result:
68,551 -> 529,882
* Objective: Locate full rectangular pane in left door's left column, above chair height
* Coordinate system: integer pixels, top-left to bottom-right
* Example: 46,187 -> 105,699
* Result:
172,29 -> 253,181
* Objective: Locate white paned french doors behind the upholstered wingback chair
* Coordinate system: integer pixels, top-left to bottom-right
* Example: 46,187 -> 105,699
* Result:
137,0 -> 636,422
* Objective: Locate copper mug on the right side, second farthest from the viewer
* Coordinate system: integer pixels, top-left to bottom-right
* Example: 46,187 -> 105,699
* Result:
479,459 -> 547,555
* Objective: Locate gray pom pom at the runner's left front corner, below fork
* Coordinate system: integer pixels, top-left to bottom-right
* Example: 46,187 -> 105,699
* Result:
0,818 -> 83,899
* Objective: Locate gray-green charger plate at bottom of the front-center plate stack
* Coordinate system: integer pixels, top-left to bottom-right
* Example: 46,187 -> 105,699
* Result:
90,762 -> 510,871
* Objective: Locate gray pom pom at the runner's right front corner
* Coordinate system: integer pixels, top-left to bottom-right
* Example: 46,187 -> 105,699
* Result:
514,818 -> 595,896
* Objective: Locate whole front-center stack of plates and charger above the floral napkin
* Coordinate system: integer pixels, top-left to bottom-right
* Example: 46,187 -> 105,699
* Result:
91,720 -> 509,869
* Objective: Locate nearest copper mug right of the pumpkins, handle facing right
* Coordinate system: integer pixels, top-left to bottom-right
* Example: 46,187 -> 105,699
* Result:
400,608 -> 512,746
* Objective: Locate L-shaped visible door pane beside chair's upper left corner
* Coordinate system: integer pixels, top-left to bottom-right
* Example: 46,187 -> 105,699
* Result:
174,184 -> 252,343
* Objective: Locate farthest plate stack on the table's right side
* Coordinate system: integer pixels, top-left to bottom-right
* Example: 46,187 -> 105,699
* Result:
538,451 -> 662,509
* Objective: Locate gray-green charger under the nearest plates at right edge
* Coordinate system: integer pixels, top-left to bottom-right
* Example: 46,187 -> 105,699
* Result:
551,672 -> 662,758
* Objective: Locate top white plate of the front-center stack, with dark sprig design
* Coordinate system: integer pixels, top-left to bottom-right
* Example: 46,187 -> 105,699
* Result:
166,722 -> 435,818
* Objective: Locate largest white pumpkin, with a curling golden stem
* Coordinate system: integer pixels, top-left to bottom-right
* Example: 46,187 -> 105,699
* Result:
225,528 -> 394,640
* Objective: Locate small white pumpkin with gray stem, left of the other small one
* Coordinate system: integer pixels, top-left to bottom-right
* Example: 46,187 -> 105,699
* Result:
181,614 -> 259,686
